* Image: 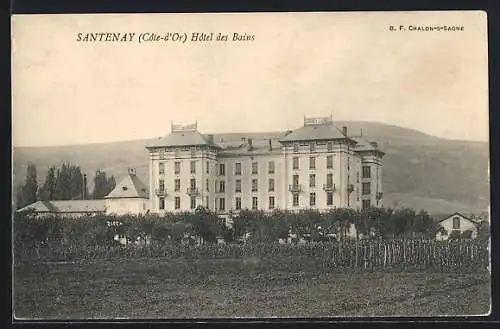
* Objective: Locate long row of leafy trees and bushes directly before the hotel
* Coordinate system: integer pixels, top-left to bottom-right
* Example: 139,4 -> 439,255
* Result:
14,207 -> 489,245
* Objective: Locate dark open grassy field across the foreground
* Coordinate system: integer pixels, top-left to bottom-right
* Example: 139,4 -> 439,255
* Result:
14,257 -> 490,319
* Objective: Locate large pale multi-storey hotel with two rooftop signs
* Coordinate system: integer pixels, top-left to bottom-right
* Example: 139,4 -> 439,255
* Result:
147,117 -> 384,215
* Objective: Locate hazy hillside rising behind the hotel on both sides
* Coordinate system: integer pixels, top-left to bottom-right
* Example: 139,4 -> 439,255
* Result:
13,122 -> 489,213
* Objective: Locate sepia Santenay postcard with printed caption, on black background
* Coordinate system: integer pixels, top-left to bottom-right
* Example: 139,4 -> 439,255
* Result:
11,11 -> 491,321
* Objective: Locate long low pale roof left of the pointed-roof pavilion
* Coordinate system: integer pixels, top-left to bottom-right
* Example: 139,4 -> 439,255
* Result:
17,200 -> 106,213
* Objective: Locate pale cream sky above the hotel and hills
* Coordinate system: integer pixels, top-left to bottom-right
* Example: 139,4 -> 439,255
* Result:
12,11 -> 489,146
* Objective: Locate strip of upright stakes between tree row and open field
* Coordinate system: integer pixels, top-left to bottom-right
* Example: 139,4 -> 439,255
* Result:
14,239 -> 490,270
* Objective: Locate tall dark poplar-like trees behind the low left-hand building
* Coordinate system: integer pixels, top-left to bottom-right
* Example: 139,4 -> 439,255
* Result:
16,163 -> 116,209
